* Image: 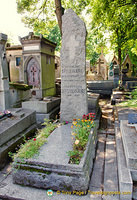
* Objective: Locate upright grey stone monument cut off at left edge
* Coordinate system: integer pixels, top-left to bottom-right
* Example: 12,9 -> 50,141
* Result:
0,33 -> 9,110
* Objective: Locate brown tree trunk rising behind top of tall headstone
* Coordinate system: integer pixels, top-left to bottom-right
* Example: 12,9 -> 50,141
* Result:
55,0 -> 63,35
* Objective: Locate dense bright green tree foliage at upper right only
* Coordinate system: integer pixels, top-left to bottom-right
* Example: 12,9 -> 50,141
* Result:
88,0 -> 137,65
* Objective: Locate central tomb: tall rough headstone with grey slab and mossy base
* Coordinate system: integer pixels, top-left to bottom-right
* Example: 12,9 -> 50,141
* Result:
13,9 -> 99,192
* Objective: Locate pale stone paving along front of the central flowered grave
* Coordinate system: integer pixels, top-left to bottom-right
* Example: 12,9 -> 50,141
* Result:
0,174 -> 93,200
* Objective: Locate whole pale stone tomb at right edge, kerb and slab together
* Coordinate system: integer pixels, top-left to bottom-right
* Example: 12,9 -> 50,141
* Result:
115,107 -> 137,200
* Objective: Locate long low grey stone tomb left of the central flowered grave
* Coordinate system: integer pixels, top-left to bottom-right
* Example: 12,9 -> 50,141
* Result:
0,109 -> 37,168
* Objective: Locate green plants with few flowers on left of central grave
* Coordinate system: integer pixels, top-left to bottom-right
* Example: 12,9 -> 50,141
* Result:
12,119 -> 58,160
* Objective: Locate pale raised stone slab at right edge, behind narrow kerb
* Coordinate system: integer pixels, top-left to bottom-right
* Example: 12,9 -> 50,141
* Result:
120,120 -> 137,170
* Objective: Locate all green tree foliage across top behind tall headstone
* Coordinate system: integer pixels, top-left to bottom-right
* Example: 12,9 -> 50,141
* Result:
17,0 -> 137,66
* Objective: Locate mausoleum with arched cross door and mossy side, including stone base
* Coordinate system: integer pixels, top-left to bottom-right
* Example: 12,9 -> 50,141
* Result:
21,33 -> 60,123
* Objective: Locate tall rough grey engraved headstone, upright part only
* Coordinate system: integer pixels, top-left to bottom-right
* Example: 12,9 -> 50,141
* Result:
61,9 -> 88,121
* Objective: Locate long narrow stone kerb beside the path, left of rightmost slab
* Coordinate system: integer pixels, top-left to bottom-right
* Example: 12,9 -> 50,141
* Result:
115,122 -> 133,200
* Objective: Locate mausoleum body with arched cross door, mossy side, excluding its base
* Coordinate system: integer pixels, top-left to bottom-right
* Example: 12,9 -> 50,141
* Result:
21,32 -> 56,99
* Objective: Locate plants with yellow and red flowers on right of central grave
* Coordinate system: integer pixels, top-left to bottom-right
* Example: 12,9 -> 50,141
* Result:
67,113 -> 95,164
